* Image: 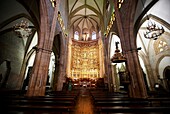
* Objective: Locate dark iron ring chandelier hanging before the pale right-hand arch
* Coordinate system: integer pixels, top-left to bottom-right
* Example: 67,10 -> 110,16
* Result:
144,19 -> 165,40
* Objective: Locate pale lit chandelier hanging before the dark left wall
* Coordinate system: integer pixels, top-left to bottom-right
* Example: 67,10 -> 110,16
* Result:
14,20 -> 32,38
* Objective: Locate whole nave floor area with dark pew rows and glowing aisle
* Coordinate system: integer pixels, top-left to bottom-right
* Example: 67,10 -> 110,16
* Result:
0,87 -> 170,114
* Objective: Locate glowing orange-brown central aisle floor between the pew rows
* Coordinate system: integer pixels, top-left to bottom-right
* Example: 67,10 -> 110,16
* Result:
75,88 -> 94,114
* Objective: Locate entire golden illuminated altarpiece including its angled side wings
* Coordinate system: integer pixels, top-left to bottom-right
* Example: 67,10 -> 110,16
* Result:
67,39 -> 104,85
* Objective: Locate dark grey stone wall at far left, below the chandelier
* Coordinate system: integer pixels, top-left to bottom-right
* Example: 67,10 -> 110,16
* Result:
0,32 -> 24,89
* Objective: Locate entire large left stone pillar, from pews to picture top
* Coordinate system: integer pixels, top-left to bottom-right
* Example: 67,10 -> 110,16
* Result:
26,0 -> 59,96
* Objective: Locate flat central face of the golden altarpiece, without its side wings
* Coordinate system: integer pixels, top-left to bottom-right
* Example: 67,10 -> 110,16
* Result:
70,42 -> 100,79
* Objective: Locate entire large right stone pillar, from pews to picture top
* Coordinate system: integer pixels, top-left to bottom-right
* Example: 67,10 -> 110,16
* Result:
113,0 -> 147,98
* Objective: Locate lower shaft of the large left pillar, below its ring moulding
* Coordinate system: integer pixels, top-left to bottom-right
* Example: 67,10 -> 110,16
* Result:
27,49 -> 51,96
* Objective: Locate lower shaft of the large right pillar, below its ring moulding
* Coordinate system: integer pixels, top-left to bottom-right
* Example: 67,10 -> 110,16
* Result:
126,50 -> 147,98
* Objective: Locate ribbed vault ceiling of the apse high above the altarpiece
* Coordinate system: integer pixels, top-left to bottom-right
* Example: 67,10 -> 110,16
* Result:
68,0 -> 104,30
